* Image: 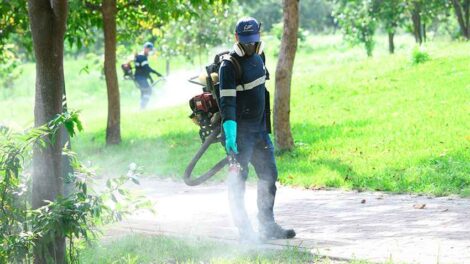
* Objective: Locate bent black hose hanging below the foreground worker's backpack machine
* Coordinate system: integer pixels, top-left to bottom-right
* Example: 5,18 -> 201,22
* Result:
183,126 -> 228,186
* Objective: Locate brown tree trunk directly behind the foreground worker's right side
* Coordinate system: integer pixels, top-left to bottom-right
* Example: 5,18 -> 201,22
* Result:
274,0 -> 299,150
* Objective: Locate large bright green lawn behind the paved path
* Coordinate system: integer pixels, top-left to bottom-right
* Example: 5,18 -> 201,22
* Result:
0,36 -> 470,196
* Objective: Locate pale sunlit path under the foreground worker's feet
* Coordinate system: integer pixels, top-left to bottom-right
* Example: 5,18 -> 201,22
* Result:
104,180 -> 470,264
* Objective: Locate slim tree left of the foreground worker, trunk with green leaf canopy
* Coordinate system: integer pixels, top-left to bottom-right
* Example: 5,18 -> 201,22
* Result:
70,0 -> 230,145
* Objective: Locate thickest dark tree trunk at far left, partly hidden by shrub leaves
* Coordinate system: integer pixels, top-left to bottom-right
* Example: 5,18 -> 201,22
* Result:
28,0 -> 68,263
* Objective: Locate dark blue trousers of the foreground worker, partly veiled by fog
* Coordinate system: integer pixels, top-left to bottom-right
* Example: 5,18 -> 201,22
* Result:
228,131 -> 278,230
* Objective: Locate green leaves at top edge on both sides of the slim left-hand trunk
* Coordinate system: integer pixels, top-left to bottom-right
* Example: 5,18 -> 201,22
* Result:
66,0 -> 229,48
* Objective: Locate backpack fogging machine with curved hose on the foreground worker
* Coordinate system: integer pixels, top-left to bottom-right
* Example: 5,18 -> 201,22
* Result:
183,52 -> 240,186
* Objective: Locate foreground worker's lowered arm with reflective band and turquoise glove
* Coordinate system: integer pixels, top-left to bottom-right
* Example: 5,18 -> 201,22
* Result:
219,61 -> 238,153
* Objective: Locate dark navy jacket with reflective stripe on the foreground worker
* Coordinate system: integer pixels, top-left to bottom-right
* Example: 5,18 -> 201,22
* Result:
219,54 -> 267,132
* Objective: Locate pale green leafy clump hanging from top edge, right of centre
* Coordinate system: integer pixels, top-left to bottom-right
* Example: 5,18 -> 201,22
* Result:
334,0 -> 377,57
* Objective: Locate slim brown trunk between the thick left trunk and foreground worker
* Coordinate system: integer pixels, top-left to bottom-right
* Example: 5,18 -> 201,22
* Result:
101,0 -> 121,145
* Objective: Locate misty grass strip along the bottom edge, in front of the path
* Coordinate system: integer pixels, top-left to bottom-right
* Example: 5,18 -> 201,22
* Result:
80,235 -> 317,264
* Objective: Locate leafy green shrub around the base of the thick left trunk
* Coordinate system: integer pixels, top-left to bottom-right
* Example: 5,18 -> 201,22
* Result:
0,112 -> 151,263
